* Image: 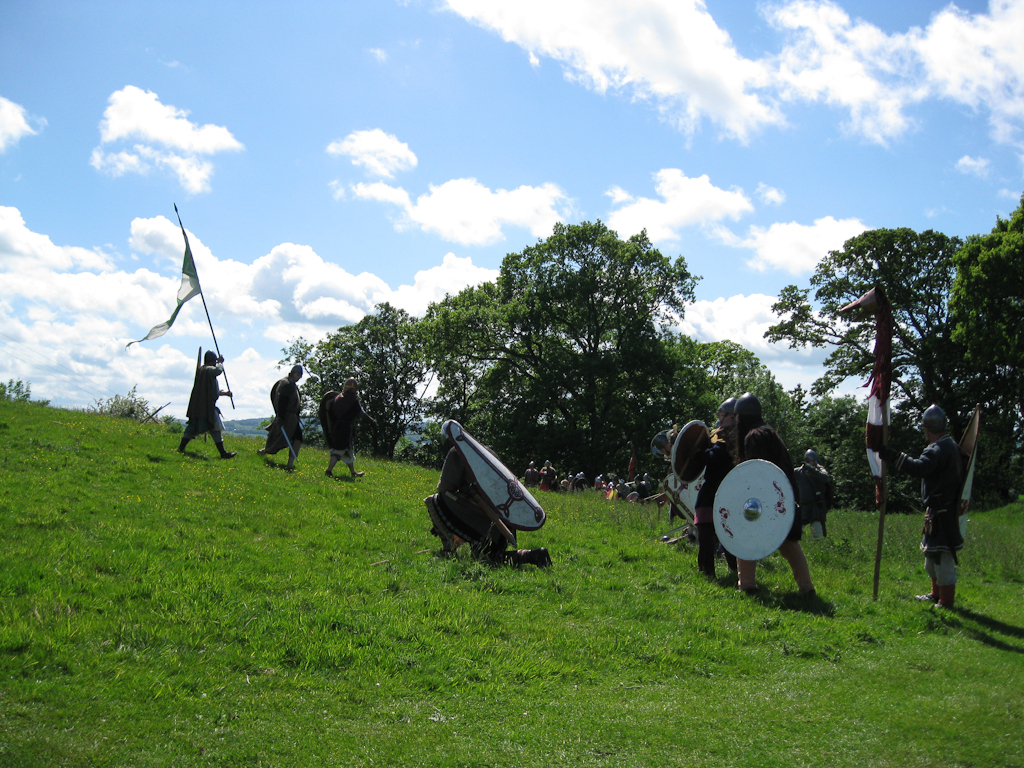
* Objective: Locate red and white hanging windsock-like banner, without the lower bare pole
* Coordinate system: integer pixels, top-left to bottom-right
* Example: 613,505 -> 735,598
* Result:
840,286 -> 893,504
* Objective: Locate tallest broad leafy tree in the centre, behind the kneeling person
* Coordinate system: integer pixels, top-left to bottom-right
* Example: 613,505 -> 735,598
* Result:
425,221 -> 708,476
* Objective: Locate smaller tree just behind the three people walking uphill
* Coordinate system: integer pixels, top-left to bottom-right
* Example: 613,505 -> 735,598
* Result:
282,302 -> 430,459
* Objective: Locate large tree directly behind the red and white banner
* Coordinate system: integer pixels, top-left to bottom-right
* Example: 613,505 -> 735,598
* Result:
766,228 -> 1009,501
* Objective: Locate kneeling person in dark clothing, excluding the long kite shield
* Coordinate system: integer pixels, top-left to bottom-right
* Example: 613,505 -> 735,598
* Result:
423,442 -> 551,568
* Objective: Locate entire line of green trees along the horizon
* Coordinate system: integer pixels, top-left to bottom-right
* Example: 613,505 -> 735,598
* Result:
281,197 -> 1024,510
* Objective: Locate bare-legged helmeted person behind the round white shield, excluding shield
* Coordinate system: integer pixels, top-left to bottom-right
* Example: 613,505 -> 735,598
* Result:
730,392 -> 814,595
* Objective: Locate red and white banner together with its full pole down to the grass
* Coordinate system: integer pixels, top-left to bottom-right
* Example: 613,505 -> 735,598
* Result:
840,286 -> 893,600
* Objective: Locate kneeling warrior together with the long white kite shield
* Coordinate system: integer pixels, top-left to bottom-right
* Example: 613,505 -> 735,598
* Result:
423,421 -> 551,567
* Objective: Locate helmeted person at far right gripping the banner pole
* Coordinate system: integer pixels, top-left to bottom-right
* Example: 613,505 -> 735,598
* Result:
878,404 -> 964,608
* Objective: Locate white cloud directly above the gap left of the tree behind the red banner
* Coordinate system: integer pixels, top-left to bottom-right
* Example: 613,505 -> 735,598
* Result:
718,216 -> 867,275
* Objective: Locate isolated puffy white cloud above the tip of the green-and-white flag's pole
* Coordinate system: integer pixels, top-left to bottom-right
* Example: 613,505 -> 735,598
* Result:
89,85 -> 245,195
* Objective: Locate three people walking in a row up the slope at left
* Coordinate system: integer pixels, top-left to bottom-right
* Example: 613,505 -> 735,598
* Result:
178,349 -> 373,478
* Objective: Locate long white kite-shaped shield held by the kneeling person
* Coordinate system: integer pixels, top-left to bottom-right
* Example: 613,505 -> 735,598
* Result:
441,420 -> 546,530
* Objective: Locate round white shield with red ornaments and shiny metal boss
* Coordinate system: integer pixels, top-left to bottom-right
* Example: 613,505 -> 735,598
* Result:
715,459 -> 797,560
